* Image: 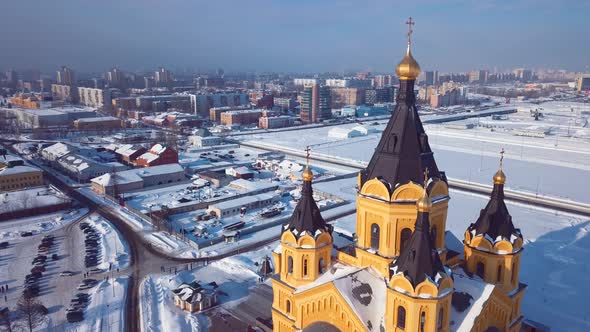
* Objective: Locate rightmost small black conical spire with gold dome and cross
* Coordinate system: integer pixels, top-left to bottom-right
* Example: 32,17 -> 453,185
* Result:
469,150 -> 520,240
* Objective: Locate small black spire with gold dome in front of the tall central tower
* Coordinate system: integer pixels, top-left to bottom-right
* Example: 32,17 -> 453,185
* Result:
392,171 -> 445,287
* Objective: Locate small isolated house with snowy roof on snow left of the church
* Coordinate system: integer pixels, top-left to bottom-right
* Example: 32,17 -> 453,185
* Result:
172,281 -> 218,312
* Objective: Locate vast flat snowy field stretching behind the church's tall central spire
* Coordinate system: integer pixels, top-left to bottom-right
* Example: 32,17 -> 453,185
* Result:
240,102 -> 590,203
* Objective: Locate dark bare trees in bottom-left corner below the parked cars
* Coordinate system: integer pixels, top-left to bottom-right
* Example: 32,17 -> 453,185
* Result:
0,295 -> 47,332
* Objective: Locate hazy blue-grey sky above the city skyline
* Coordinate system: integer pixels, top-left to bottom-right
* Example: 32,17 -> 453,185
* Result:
0,0 -> 590,72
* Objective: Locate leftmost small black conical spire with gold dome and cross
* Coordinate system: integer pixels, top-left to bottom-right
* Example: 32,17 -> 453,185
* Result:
284,147 -> 329,236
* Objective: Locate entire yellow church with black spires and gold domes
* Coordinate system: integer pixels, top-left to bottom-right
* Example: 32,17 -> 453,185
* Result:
272,18 -> 526,332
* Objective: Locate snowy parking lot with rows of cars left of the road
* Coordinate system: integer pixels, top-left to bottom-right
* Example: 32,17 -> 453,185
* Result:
0,213 -> 129,331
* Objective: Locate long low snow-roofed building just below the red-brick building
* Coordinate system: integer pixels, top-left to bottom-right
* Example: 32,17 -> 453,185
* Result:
90,164 -> 186,195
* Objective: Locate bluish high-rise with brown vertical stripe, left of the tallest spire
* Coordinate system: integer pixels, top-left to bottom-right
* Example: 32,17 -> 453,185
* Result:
299,84 -> 332,123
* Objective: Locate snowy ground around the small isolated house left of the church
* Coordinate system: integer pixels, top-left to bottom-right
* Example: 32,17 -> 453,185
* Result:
140,243 -> 276,332
